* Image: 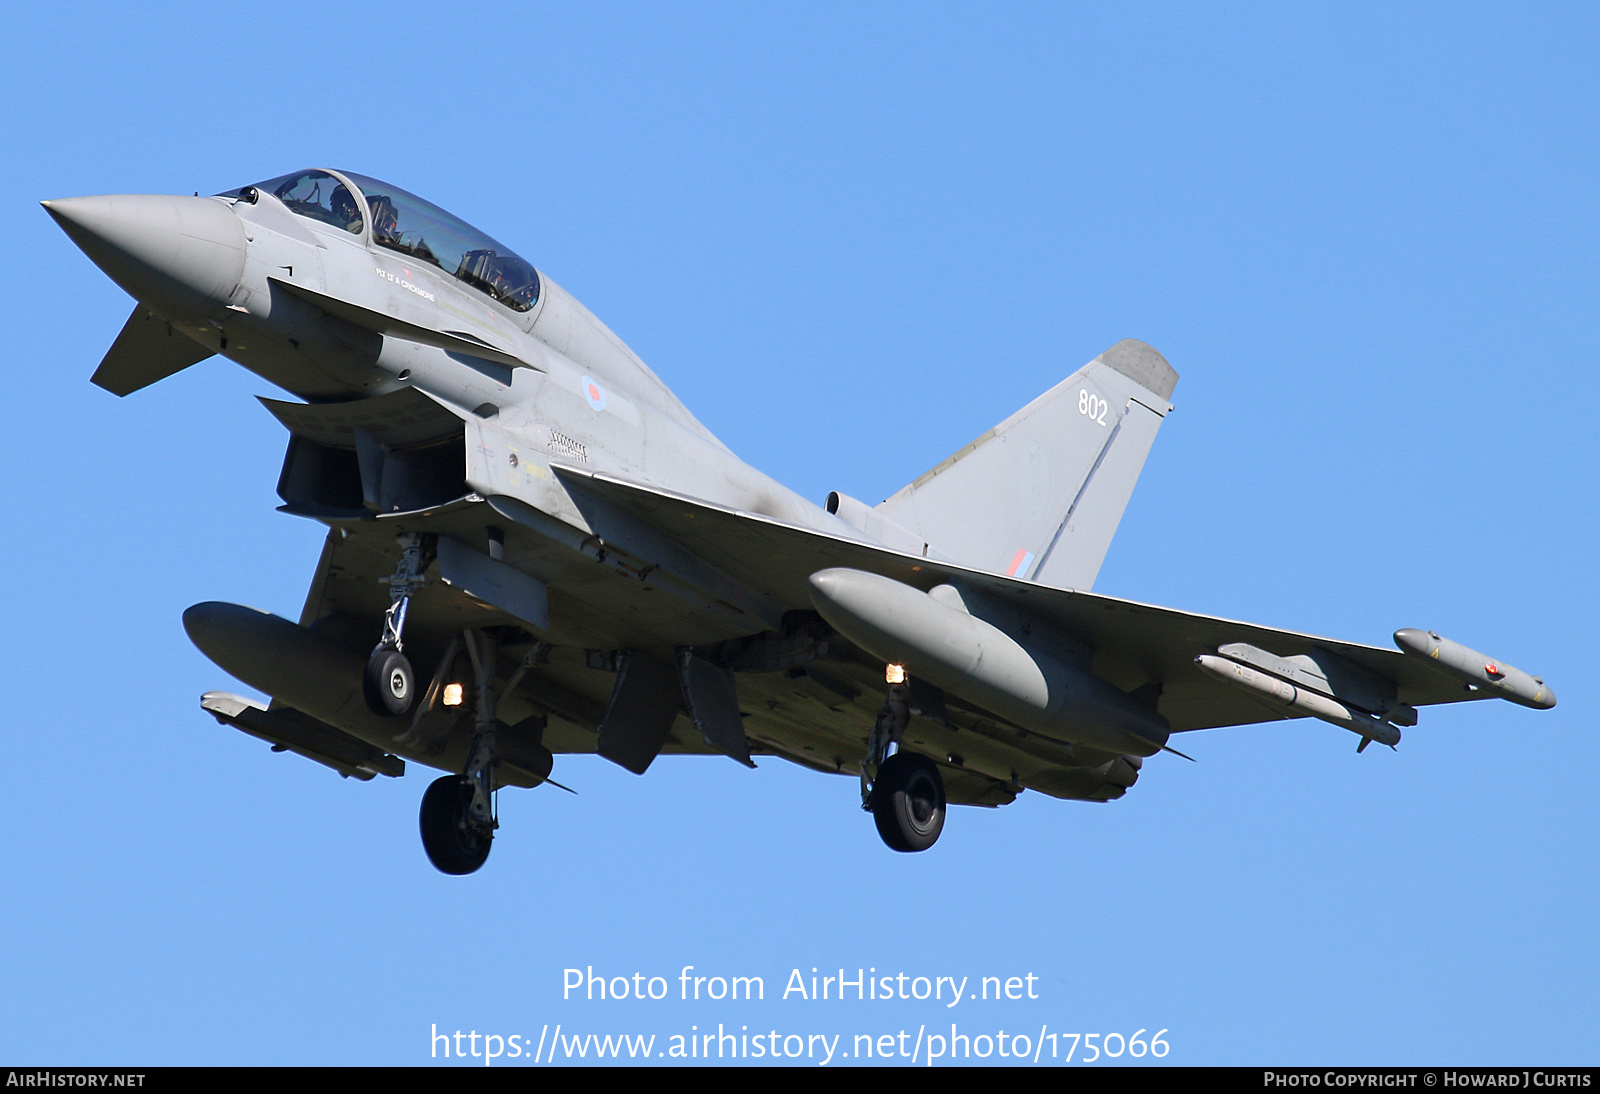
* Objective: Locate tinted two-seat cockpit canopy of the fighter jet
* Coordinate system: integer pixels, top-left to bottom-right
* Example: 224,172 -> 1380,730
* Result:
238,171 -> 539,312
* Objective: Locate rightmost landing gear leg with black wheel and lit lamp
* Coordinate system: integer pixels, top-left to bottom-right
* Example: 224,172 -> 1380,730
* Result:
861,665 -> 944,851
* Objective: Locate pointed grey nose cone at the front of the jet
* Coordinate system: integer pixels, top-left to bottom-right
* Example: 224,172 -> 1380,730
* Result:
42,194 -> 248,317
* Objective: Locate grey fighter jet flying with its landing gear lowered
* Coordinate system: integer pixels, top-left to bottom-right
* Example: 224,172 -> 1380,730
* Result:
43,170 -> 1555,873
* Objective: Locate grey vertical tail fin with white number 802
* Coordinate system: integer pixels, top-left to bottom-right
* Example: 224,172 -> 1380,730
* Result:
878,337 -> 1178,589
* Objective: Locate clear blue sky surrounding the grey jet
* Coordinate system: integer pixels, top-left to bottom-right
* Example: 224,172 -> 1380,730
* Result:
0,3 -> 1600,1064
